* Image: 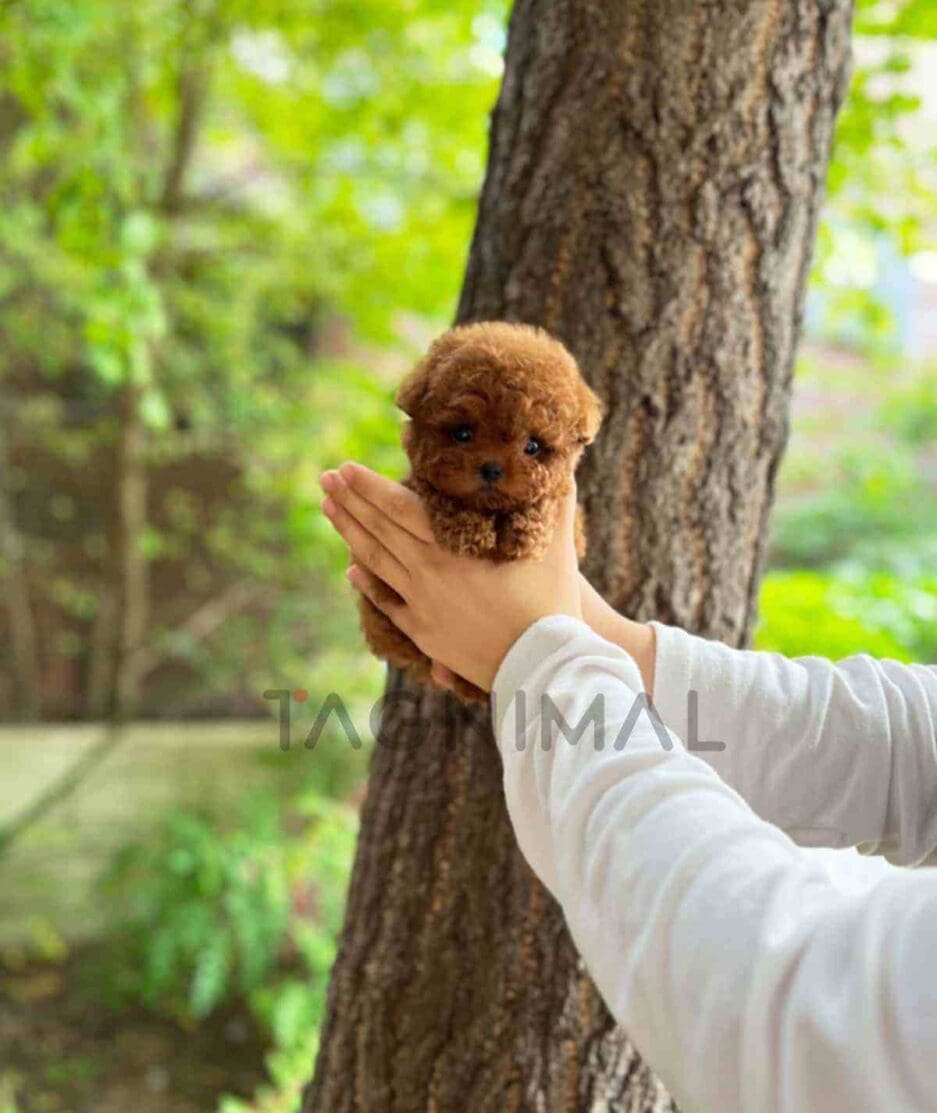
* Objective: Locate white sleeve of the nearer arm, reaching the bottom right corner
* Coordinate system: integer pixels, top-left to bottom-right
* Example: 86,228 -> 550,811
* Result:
493,617 -> 937,1113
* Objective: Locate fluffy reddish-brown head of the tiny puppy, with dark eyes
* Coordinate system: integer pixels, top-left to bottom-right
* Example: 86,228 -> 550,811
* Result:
397,322 -> 601,511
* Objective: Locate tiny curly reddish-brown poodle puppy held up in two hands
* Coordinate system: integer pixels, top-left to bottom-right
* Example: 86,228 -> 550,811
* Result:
361,322 -> 601,700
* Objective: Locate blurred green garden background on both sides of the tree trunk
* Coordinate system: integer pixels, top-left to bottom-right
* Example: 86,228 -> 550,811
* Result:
0,0 -> 937,1113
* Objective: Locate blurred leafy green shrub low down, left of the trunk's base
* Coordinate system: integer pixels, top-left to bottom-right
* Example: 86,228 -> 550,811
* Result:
99,790 -> 356,1111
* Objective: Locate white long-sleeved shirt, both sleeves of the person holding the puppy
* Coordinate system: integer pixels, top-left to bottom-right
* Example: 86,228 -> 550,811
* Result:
493,615 -> 937,1113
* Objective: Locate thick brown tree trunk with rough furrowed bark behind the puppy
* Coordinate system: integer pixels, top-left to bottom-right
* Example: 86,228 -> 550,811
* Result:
304,0 -> 851,1113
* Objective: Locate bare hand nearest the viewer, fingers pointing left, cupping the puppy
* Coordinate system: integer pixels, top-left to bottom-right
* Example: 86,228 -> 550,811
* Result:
320,463 -> 581,691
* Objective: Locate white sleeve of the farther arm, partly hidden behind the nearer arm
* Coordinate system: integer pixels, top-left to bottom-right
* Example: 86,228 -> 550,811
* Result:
653,622 -> 937,865
